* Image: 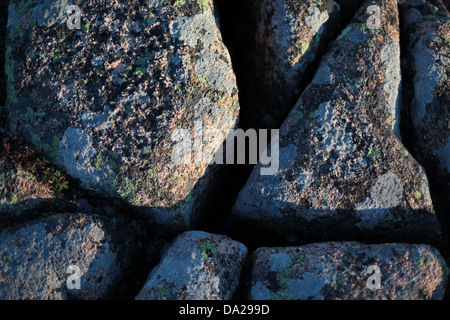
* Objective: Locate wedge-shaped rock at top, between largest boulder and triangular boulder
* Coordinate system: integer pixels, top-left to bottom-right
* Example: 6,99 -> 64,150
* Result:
244,0 -> 358,128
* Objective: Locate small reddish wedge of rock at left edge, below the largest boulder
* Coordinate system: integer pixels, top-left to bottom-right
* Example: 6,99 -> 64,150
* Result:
0,152 -> 74,227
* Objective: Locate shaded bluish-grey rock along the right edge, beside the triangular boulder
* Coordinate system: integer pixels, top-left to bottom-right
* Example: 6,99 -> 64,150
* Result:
403,2 -> 450,202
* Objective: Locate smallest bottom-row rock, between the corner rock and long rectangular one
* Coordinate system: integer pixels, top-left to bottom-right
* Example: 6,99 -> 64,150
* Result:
136,231 -> 247,300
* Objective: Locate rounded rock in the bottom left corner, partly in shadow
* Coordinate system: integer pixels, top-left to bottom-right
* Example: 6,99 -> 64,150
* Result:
0,214 -> 136,300
